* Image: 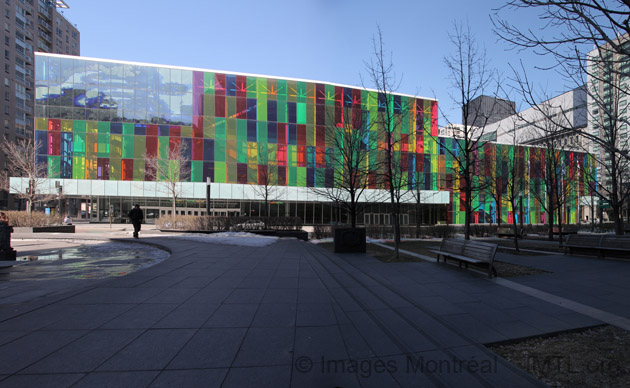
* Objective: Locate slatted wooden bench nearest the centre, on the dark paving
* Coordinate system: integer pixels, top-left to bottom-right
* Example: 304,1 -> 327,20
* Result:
431,238 -> 497,278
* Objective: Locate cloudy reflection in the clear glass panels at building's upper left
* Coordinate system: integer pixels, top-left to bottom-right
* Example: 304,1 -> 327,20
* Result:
35,57 -> 193,125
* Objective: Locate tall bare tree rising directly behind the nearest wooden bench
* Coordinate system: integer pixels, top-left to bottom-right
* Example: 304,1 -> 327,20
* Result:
436,23 -> 500,239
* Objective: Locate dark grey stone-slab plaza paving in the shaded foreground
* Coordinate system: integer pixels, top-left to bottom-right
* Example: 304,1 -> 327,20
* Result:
0,237 -> 616,388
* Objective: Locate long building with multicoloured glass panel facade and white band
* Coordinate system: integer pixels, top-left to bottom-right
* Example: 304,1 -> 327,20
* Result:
18,54 -> 587,224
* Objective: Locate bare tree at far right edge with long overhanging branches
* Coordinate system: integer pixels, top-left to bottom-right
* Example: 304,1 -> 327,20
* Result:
493,0 -> 630,234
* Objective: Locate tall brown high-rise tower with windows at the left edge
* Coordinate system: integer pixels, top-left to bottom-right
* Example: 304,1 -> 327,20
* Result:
0,0 -> 80,209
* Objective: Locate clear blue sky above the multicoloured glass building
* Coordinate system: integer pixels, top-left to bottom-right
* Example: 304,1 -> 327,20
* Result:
64,0 -> 570,125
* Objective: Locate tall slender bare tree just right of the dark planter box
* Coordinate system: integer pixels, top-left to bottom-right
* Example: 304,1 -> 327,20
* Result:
365,27 -> 408,257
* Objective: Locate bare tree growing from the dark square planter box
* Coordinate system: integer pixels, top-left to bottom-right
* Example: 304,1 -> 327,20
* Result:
312,108 -> 377,228
